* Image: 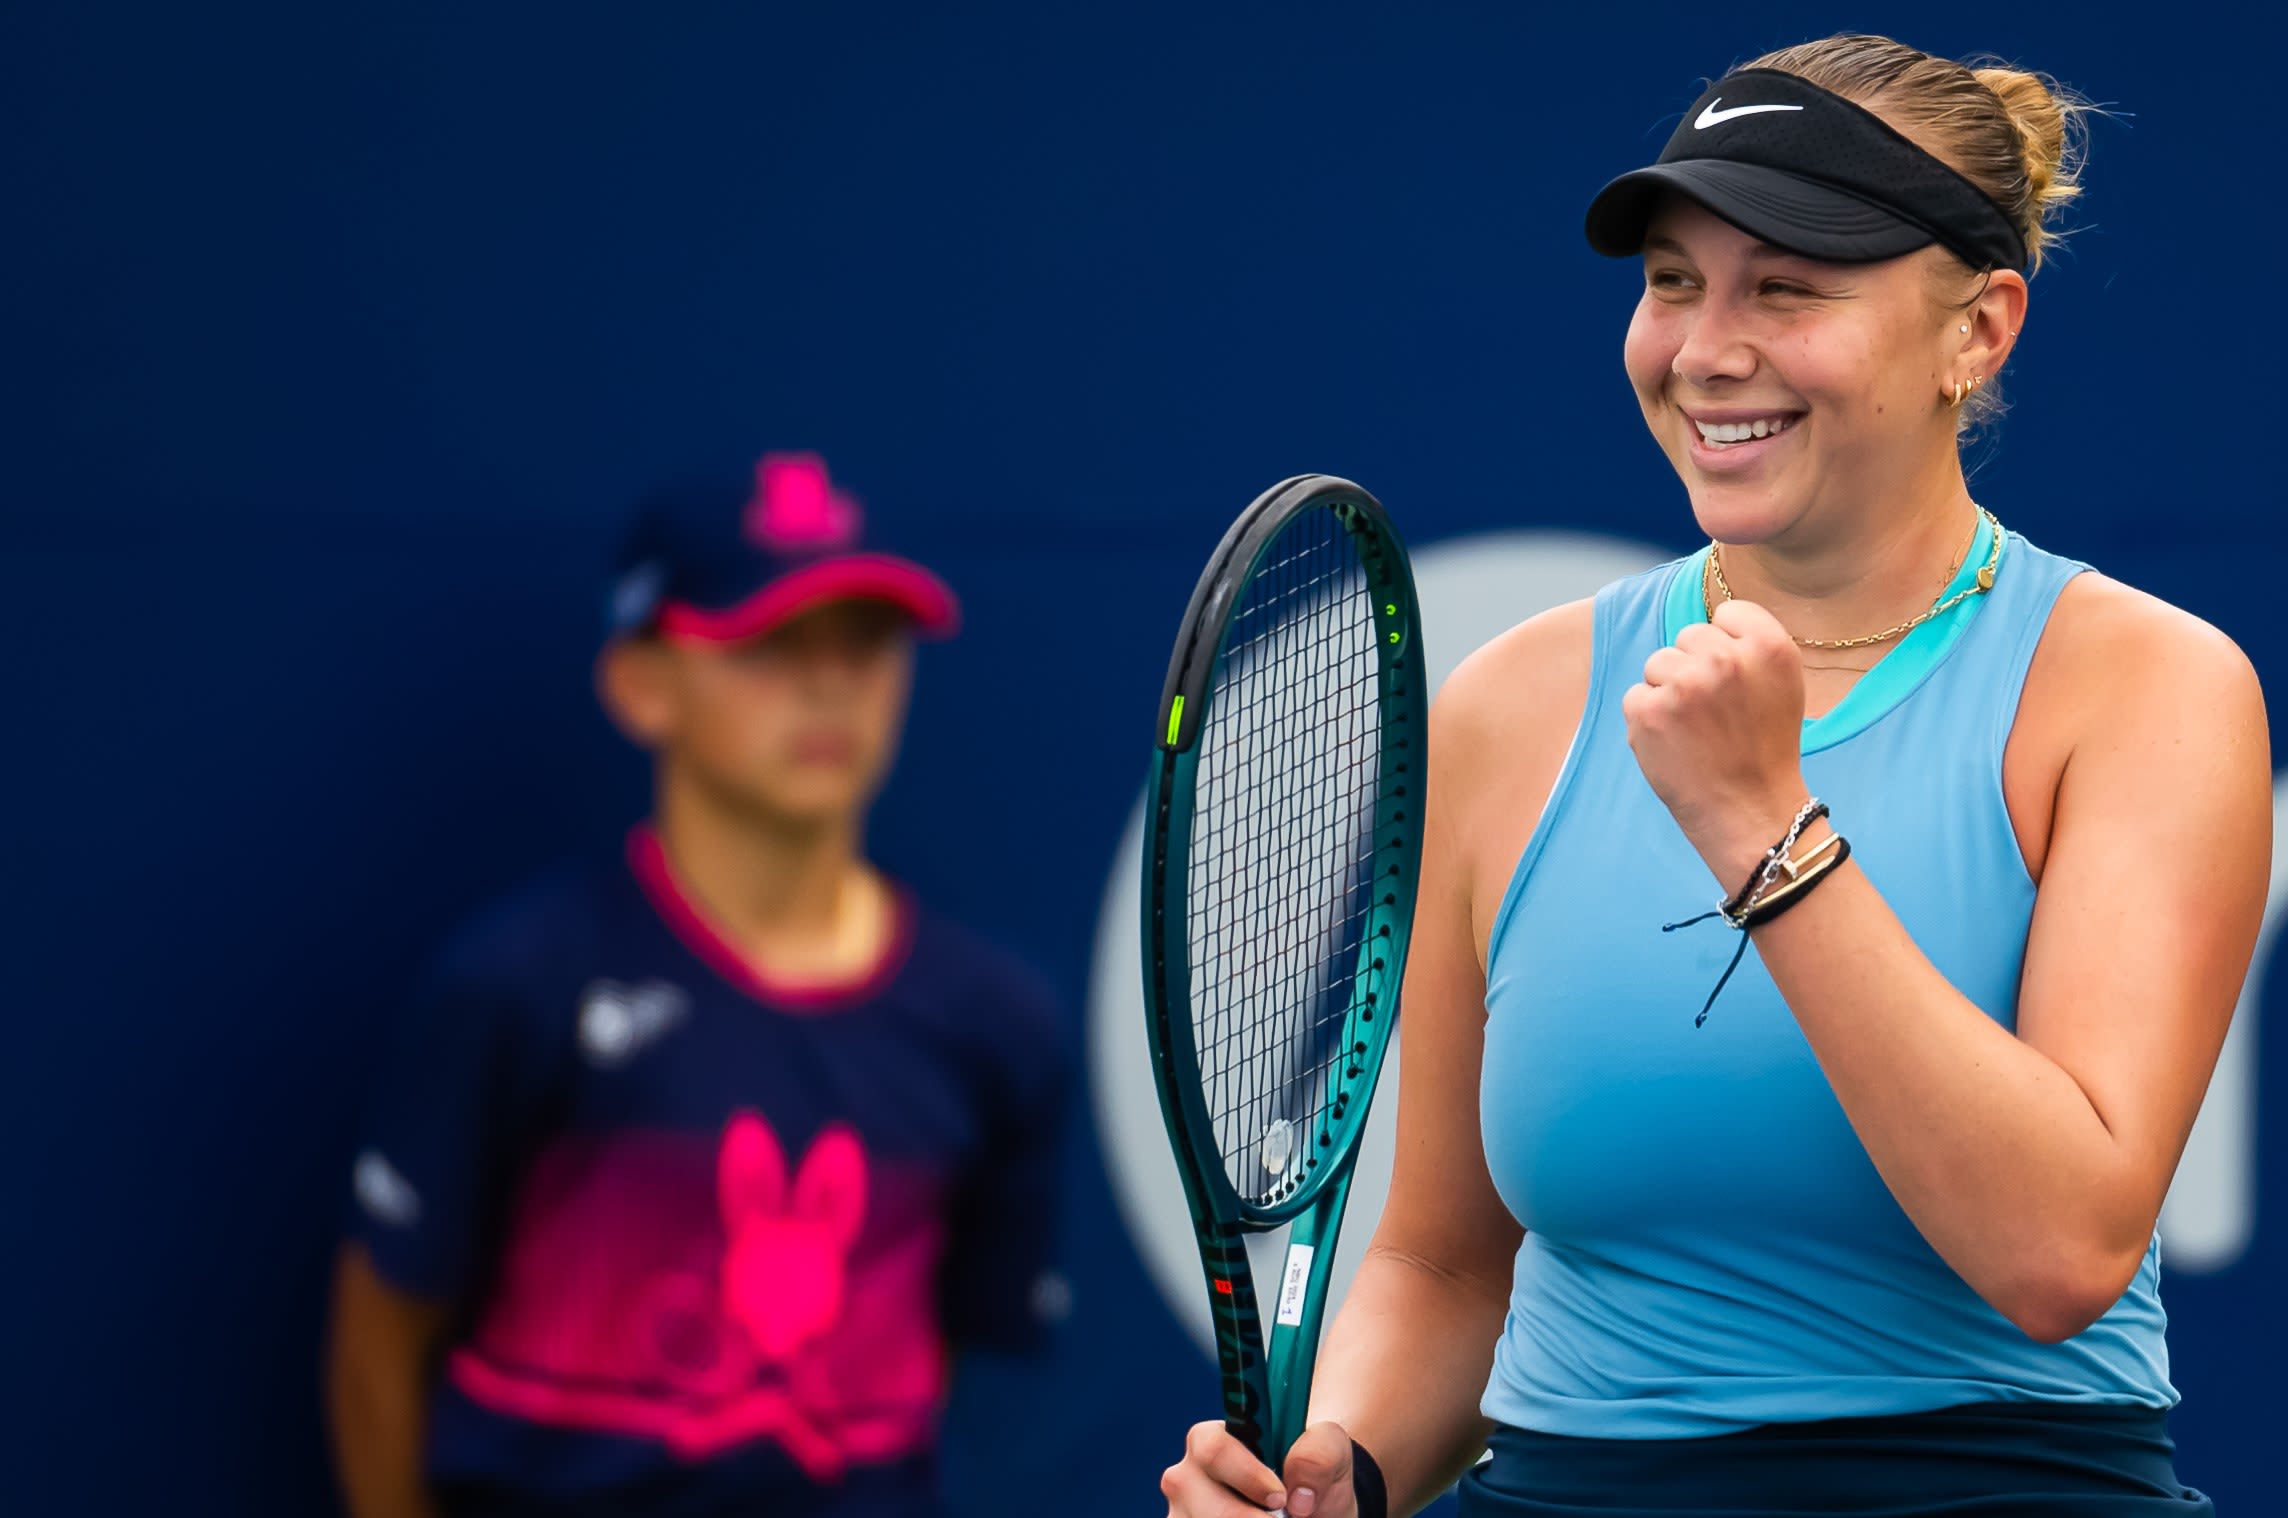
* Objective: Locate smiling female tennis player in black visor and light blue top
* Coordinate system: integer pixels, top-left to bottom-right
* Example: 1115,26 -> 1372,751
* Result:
1162,26 -> 2270,1518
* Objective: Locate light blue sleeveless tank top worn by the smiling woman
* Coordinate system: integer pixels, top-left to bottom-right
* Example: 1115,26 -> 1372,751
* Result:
1480,519 -> 2176,1438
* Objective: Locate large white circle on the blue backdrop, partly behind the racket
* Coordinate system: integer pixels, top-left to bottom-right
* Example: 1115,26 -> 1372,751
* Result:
1089,531 -> 1673,1355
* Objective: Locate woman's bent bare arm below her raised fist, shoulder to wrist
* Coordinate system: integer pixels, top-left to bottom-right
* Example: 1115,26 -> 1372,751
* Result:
1631,577 -> 2272,1342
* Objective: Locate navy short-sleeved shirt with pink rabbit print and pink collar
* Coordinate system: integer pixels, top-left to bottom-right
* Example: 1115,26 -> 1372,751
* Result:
352,829 -> 1066,1518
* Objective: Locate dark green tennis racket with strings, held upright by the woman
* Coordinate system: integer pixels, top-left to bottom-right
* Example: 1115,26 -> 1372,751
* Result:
1144,474 -> 1428,1470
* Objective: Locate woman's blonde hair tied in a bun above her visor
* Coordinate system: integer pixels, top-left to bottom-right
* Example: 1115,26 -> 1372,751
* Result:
1748,34 -> 2089,272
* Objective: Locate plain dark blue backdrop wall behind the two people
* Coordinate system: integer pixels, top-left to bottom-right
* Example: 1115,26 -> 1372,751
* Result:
0,0 -> 2288,1516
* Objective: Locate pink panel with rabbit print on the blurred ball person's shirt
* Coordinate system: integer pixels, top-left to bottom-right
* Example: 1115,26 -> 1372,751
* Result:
453,1110 -> 945,1481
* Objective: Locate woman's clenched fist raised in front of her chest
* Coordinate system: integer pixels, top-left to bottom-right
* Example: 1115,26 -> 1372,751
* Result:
1620,600 -> 1805,893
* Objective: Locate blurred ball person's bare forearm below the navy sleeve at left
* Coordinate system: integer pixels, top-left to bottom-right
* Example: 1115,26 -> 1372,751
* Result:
325,1243 -> 446,1518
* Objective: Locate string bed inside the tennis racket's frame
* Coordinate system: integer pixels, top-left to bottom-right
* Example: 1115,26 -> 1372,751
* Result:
1187,511 -> 1382,1204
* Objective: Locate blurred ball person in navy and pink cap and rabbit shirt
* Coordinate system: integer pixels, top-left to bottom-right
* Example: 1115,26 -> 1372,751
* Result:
327,456 -> 1064,1518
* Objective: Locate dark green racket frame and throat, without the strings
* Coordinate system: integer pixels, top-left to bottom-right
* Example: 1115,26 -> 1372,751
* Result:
1144,474 -> 1430,1470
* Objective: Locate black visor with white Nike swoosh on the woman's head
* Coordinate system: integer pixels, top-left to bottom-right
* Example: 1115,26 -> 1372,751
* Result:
1588,69 -> 2025,270
